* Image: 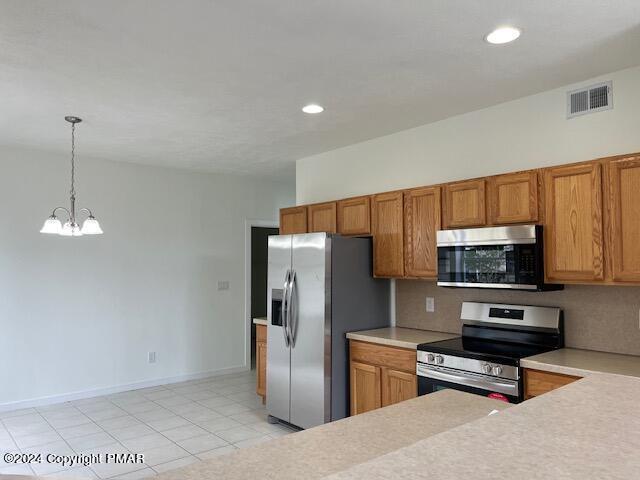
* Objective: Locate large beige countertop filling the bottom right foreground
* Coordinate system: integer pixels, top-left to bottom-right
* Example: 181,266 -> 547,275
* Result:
327,374 -> 640,480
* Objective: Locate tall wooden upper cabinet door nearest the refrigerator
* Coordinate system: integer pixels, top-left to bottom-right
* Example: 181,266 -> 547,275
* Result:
371,192 -> 404,277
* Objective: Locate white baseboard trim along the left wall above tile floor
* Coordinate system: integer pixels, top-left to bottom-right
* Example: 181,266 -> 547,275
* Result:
0,366 -> 250,412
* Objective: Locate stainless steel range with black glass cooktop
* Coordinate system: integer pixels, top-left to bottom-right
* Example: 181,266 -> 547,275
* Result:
417,302 -> 564,403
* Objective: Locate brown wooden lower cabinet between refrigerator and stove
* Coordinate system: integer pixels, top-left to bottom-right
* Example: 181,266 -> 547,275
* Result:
349,340 -> 418,415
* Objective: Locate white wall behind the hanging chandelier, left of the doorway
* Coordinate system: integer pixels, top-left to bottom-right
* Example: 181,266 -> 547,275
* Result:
0,150 -> 294,408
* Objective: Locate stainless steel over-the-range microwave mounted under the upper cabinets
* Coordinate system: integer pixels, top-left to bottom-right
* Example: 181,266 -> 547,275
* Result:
437,225 -> 563,291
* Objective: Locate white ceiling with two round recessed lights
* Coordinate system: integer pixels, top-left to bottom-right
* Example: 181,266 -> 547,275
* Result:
0,0 -> 640,176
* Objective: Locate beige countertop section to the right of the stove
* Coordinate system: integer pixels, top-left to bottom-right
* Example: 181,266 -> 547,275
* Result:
520,348 -> 640,377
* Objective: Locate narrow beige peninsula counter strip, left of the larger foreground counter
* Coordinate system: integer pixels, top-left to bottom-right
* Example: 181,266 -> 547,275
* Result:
159,390 -> 510,480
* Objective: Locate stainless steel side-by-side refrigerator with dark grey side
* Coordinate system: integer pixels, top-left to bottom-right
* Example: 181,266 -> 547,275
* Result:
267,233 -> 390,428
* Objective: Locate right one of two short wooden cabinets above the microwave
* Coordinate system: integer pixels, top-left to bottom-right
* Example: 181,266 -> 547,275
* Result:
487,172 -> 539,225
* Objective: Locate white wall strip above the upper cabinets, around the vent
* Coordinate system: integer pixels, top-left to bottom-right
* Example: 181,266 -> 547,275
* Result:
296,63 -> 640,205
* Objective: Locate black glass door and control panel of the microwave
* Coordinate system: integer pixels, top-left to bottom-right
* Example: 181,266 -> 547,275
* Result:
438,244 -> 536,285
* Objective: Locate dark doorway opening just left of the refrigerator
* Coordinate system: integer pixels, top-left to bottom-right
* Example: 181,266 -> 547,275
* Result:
248,226 -> 279,370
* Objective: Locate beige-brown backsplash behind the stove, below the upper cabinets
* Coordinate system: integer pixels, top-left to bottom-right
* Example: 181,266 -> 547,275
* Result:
396,280 -> 640,355
